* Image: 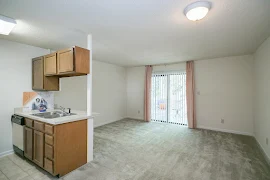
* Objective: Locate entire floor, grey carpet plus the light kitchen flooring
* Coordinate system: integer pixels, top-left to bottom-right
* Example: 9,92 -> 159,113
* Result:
0,119 -> 270,180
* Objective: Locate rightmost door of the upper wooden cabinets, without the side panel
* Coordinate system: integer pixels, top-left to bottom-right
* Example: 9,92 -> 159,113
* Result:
57,48 -> 75,74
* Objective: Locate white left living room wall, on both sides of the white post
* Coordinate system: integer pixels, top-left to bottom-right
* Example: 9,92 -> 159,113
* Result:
55,61 -> 127,127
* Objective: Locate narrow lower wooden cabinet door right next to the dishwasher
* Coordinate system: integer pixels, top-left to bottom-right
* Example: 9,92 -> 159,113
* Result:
24,127 -> 33,160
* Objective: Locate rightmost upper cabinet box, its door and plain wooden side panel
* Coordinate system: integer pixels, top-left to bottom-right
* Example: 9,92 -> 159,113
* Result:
57,46 -> 90,76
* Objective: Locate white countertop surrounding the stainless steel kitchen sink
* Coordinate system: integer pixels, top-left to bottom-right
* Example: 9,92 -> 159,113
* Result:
14,108 -> 99,125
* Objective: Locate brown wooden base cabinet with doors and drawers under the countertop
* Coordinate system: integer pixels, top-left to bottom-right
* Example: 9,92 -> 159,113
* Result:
25,118 -> 87,176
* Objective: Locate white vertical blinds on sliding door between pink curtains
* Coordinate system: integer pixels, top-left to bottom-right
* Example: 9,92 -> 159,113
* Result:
151,72 -> 187,126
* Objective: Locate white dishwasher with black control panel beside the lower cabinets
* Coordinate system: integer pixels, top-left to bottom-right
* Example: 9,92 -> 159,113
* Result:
11,114 -> 25,156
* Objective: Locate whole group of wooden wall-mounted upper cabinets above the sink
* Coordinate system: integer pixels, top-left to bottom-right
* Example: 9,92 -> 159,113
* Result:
32,46 -> 90,91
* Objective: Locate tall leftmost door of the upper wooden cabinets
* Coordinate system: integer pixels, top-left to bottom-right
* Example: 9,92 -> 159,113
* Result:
32,57 -> 44,90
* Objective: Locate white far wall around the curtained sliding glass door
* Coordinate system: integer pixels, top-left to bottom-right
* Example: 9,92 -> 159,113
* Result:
127,55 -> 253,135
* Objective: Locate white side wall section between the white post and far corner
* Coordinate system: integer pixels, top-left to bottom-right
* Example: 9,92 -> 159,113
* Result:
92,61 -> 127,127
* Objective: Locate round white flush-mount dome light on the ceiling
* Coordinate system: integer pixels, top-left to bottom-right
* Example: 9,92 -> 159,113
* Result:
184,1 -> 211,21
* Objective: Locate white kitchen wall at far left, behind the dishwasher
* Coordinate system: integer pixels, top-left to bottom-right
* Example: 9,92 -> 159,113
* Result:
0,39 -> 49,156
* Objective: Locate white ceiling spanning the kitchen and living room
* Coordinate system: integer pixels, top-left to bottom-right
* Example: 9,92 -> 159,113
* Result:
0,0 -> 270,66
